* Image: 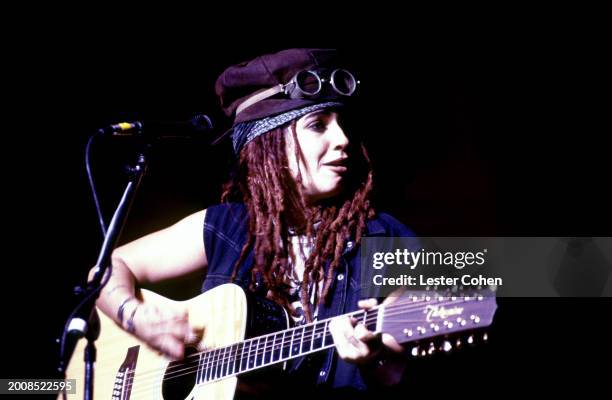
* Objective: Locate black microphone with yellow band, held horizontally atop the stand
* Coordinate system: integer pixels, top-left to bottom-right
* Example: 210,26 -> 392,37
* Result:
98,114 -> 213,139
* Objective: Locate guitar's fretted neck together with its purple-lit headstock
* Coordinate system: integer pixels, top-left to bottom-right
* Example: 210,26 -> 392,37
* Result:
197,294 -> 496,383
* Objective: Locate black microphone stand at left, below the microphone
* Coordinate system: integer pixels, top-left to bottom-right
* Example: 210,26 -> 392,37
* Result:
59,144 -> 151,400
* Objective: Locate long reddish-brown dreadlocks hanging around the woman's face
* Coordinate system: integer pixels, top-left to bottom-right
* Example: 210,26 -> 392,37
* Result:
221,121 -> 375,322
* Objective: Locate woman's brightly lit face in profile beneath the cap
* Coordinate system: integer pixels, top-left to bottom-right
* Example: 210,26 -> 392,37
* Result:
287,109 -> 349,204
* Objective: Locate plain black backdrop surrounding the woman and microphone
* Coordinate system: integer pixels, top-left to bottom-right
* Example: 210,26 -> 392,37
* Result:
2,10 -> 611,397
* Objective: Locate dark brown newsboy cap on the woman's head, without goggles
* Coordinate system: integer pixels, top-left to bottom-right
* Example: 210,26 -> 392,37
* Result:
215,49 -> 346,126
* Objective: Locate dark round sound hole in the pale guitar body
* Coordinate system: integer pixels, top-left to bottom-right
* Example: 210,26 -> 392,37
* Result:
162,348 -> 199,400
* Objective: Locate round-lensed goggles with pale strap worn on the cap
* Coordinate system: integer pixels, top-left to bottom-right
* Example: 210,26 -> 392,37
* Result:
236,68 -> 359,115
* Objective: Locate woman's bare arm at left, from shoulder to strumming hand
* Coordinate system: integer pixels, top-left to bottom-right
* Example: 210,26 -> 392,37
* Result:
90,210 -> 208,359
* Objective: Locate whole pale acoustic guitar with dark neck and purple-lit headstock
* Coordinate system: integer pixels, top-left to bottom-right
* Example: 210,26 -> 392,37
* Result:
59,284 -> 497,400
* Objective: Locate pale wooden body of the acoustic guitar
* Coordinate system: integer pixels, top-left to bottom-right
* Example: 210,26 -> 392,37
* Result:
60,284 -> 288,400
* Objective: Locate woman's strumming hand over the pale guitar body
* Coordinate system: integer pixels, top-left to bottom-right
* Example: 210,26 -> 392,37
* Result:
133,303 -> 202,360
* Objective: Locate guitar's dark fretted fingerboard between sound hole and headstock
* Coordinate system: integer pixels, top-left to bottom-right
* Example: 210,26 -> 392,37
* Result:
196,308 -> 372,384
